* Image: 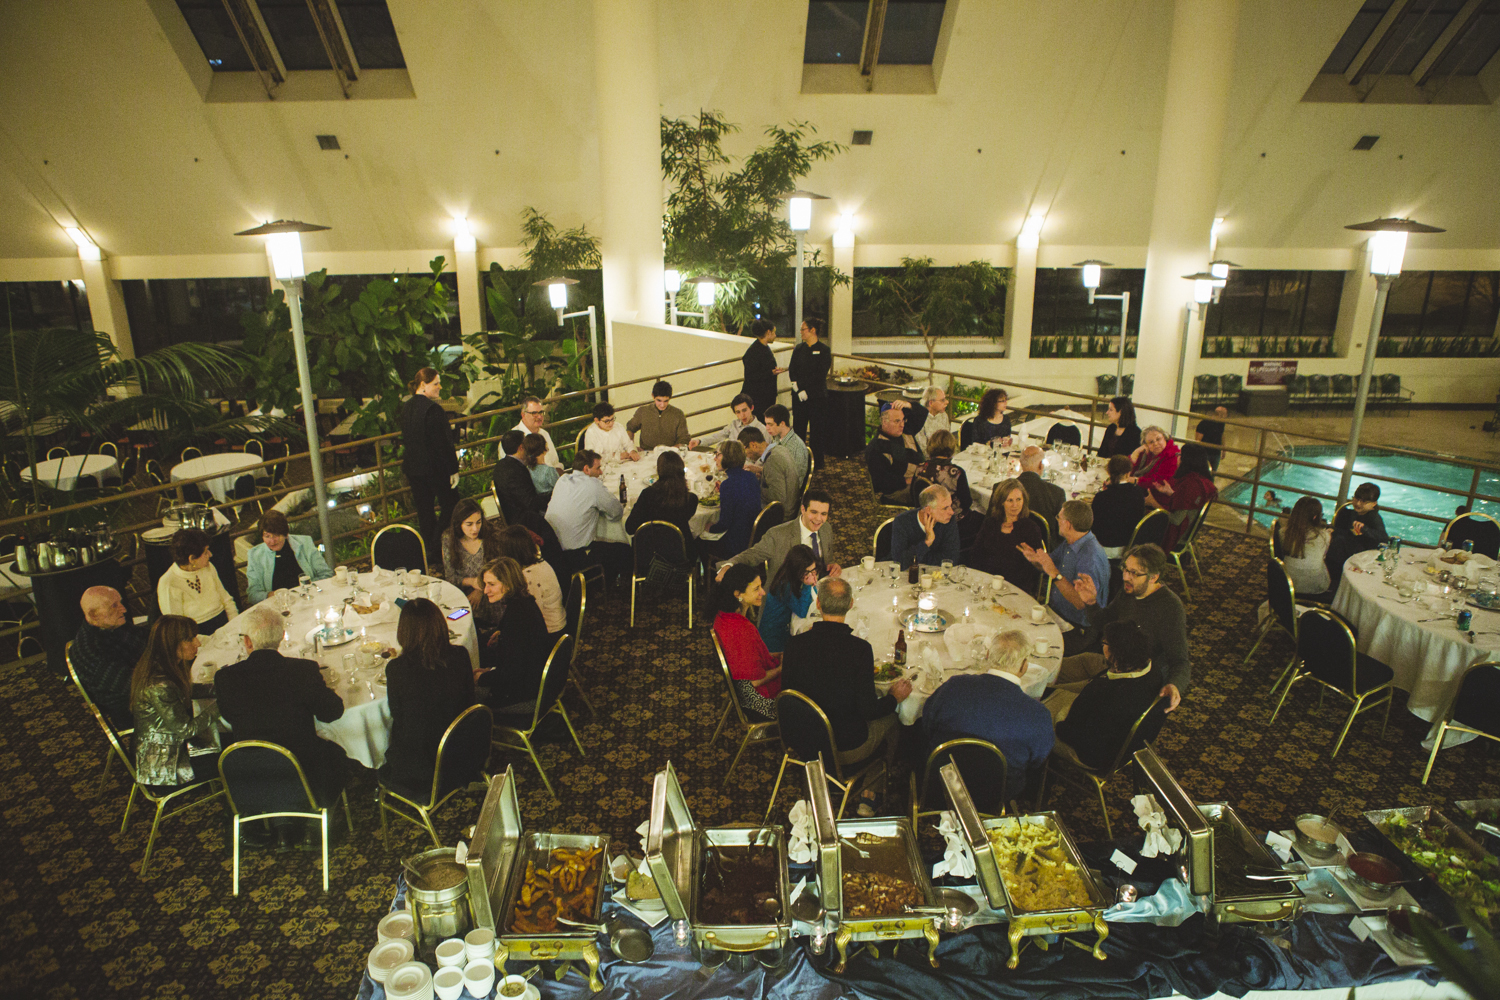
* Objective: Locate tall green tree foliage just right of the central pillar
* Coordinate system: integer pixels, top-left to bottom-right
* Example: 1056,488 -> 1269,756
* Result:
662,111 -> 849,331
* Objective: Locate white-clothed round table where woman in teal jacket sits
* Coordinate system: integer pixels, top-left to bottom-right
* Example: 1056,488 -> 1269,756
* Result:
192,571 -> 479,768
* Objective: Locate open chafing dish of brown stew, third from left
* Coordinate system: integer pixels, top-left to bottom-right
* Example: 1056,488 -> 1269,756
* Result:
806,760 -> 945,973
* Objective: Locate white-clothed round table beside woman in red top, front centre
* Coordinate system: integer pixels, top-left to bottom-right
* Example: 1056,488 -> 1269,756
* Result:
828,562 -> 1062,726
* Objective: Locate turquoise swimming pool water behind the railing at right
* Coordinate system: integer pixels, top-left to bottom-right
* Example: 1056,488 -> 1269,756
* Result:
1221,445 -> 1500,544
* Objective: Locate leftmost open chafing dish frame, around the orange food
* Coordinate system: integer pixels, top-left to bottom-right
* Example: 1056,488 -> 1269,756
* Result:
465,768 -> 609,993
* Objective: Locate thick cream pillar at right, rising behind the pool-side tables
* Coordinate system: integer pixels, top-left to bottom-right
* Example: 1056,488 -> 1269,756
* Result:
1134,0 -> 1239,413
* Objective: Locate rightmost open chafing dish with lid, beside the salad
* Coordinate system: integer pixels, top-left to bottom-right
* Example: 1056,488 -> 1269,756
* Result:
1136,747 -> 1304,924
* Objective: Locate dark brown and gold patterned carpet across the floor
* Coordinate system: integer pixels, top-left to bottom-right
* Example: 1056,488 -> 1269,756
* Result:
0,460 -> 1500,1000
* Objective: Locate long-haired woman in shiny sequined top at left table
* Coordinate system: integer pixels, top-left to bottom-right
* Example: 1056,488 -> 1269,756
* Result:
131,615 -> 219,787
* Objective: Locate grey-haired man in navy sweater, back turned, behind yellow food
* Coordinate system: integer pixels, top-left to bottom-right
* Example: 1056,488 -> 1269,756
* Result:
923,630 -> 1053,802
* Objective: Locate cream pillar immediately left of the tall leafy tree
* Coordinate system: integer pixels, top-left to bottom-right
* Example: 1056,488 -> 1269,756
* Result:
594,0 -> 665,380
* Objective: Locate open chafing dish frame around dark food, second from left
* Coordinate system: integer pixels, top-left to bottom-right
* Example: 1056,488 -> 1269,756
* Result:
647,763 -> 792,952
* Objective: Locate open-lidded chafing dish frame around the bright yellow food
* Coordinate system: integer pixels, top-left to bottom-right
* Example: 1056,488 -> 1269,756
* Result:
941,763 -> 1110,969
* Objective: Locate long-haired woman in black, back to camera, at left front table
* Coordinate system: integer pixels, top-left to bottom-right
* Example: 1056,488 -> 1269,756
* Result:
380,597 -> 479,801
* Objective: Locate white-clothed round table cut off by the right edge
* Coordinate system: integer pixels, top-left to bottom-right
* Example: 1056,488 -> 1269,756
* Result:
1334,549 -> 1500,747
